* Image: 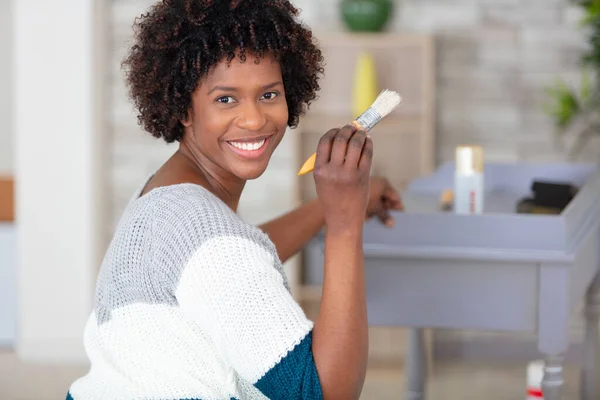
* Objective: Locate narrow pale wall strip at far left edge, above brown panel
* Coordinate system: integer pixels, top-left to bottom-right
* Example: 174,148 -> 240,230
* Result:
0,0 -> 13,175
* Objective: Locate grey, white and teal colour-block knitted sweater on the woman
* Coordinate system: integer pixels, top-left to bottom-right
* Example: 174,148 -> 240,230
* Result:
67,184 -> 322,400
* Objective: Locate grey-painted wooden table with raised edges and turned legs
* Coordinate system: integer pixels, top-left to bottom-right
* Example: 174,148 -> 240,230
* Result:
306,163 -> 600,400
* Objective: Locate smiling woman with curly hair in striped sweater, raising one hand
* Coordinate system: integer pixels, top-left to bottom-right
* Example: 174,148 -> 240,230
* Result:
67,0 -> 401,400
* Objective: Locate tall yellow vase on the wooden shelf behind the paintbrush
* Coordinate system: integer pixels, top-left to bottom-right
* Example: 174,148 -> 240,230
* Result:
352,53 -> 379,118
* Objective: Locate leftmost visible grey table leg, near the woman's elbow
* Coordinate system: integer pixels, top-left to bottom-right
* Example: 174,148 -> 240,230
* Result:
406,328 -> 427,400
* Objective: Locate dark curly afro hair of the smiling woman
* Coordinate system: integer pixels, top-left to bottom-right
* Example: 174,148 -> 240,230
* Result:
123,0 -> 323,143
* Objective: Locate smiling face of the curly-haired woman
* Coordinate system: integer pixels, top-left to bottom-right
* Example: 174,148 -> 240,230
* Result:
183,55 -> 288,180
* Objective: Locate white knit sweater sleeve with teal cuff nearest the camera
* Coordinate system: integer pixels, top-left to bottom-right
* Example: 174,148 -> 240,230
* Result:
176,236 -> 322,399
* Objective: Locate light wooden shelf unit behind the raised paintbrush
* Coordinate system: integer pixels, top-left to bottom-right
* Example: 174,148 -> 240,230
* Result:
291,33 -> 435,366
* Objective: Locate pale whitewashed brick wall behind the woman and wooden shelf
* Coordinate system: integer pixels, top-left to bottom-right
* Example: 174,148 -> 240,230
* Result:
109,0 -> 586,220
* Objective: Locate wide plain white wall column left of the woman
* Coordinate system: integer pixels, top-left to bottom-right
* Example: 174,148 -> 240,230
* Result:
14,0 -> 105,363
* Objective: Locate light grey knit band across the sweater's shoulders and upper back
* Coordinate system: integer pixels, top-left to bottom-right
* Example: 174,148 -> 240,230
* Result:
95,184 -> 289,324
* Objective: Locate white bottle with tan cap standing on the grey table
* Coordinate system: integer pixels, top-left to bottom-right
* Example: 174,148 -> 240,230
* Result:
454,146 -> 484,214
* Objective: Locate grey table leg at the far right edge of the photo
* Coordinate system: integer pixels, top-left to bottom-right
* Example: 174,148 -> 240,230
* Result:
580,275 -> 600,400
